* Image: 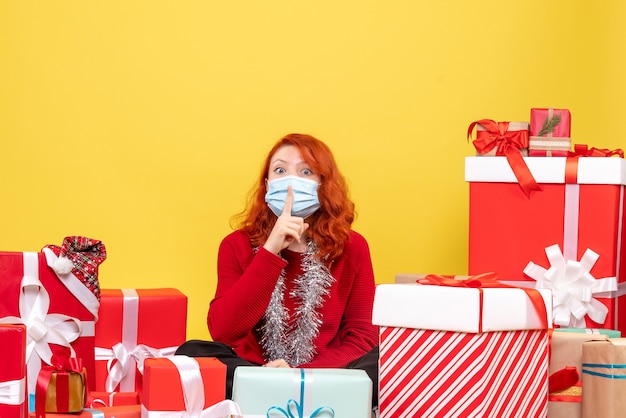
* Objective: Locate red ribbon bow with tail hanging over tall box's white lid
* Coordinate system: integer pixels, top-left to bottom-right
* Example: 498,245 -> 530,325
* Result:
467,119 -> 542,197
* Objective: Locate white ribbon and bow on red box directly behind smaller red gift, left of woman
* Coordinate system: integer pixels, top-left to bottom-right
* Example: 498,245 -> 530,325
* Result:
95,289 -> 178,392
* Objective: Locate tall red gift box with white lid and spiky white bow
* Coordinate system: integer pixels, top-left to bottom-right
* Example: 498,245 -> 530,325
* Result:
465,155 -> 626,332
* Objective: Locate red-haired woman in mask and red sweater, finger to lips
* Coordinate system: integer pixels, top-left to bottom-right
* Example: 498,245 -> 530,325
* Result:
177,134 -> 378,403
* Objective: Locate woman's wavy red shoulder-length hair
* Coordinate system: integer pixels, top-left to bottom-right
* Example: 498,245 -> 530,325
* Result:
235,134 -> 355,263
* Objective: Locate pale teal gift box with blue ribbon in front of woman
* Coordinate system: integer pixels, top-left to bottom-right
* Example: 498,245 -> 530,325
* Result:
233,366 -> 372,418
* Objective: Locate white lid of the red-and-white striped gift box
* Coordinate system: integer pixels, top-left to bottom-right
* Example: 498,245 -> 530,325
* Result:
372,283 -> 552,333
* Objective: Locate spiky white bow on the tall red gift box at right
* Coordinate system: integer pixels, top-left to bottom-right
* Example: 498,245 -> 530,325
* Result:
524,244 -> 617,328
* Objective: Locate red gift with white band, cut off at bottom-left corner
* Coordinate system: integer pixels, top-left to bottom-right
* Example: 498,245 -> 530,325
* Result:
0,324 -> 28,418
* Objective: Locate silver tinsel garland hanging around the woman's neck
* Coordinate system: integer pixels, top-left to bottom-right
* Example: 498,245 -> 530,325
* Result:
260,240 -> 335,367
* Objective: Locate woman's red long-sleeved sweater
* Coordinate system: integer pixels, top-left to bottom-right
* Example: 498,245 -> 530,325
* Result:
207,231 -> 378,367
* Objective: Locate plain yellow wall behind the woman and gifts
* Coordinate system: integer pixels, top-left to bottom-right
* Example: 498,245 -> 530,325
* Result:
0,0 -> 626,338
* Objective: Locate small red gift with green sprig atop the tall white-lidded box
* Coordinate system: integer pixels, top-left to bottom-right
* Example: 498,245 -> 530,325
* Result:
528,108 -> 571,157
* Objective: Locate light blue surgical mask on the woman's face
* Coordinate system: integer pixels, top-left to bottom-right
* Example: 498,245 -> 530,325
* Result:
265,176 -> 320,218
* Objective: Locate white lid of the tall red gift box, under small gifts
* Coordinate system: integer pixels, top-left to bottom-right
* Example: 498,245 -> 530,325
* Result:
465,157 -> 626,185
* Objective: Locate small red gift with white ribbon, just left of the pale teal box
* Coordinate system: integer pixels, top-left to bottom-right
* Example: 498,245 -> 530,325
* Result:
141,356 -> 227,418
